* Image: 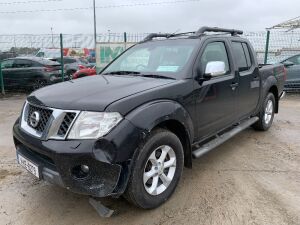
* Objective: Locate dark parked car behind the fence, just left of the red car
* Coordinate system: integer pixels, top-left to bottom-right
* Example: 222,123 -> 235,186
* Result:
51,56 -> 92,78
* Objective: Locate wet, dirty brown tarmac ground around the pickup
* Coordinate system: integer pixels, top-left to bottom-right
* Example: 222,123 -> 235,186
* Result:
0,95 -> 300,225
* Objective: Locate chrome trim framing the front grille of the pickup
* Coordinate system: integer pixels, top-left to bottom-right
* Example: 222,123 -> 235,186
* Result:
21,101 -> 80,140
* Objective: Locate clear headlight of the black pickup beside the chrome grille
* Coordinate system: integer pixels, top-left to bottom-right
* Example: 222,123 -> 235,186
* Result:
68,112 -> 123,139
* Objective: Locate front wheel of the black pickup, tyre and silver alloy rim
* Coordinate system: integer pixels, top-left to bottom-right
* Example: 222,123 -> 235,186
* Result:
124,129 -> 184,209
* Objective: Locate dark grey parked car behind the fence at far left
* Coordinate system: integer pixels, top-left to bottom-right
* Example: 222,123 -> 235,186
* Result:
1,57 -> 62,90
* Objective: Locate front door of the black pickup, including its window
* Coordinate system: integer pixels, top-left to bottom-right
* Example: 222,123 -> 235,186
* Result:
194,38 -> 237,140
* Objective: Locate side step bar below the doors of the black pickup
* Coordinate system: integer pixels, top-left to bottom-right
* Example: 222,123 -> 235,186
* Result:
193,116 -> 258,158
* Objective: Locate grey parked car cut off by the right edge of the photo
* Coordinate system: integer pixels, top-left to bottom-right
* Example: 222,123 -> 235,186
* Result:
281,54 -> 300,92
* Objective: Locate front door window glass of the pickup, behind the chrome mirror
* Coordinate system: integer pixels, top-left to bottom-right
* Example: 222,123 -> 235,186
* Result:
200,41 -> 230,74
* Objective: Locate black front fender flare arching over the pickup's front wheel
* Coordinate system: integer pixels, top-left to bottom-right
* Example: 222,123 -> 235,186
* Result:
125,100 -> 194,143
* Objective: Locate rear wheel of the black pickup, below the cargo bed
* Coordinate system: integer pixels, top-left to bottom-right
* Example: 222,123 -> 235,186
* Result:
253,93 -> 275,131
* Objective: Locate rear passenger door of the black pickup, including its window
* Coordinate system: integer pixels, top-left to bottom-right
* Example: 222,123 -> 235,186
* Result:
231,41 -> 260,119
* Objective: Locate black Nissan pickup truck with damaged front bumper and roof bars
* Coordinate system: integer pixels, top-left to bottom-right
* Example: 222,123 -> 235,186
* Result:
13,27 -> 285,209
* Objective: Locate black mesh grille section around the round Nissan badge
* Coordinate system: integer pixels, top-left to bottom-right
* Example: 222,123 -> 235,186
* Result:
25,104 -> 53,133
